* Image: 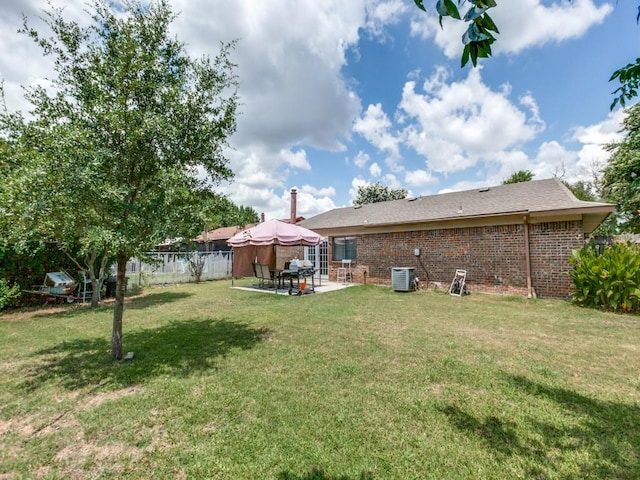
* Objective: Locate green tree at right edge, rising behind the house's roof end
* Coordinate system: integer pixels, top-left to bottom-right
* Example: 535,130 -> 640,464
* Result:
602,104 -> 640,233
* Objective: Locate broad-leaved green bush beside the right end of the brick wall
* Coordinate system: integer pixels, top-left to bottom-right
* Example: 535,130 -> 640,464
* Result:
569,243 -> 640,312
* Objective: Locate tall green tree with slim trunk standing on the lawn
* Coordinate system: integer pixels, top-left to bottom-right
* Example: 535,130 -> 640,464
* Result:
3,0 -> 237,359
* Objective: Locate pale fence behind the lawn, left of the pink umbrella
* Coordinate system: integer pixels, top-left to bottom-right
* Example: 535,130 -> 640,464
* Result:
127,251 -> 233,288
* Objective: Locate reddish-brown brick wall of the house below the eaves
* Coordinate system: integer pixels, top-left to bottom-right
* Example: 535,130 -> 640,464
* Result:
329,221 -> 582,297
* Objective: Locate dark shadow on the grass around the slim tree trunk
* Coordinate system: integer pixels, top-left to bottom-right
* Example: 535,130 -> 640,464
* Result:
23,318 -> 268,391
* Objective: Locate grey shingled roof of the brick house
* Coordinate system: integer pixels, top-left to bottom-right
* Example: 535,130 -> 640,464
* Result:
301,178 -> 615,234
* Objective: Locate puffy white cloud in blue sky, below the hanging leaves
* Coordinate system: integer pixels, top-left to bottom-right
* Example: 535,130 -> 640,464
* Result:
399,68 -> 544,174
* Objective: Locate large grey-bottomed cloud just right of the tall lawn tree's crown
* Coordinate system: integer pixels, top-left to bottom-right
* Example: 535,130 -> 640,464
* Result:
173,0 -> 365,150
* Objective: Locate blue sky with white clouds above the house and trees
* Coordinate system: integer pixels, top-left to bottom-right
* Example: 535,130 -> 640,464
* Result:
0,0 -> 640,218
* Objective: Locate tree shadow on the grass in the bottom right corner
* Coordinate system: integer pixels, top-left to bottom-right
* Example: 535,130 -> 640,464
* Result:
441,375 -> 640,479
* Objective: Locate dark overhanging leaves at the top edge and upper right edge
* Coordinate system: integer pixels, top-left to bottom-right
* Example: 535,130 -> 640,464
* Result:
414,0 -> 640,110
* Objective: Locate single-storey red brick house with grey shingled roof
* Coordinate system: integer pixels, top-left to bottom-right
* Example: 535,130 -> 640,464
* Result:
300,178 -> 614,298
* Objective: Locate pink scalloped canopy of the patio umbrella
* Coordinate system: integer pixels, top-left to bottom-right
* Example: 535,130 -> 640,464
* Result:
227,220 -> 324,248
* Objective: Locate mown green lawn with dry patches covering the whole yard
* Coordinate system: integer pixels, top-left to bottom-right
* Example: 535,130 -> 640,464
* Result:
0,281 -> 640,480
